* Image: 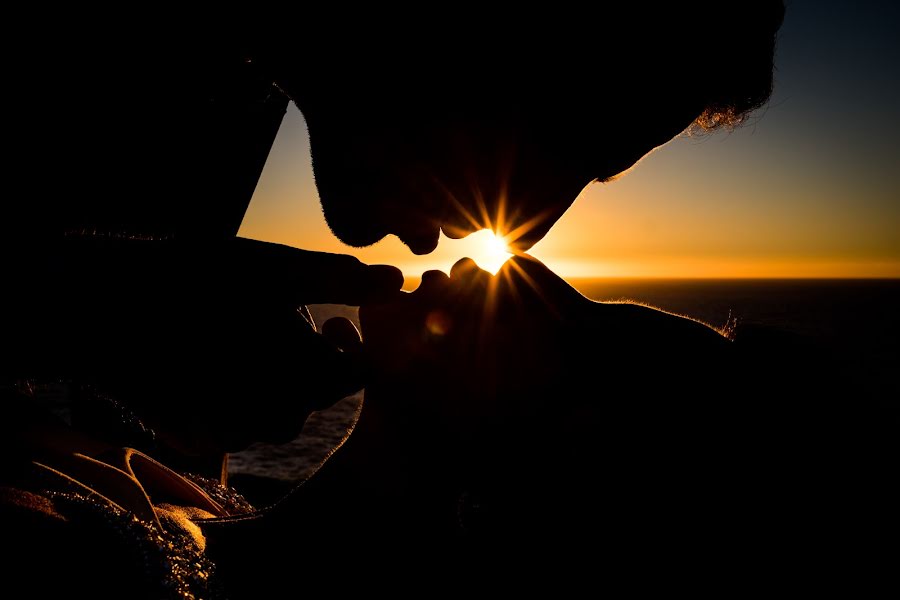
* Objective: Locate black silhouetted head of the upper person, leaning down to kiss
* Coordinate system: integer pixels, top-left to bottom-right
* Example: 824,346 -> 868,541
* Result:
259,0 -> 783,253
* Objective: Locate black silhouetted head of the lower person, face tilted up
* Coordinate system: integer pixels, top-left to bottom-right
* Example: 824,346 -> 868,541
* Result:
351,256 -> 735,533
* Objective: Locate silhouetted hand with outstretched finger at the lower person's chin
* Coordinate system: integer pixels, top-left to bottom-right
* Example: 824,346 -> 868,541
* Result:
13,238 -> 402,454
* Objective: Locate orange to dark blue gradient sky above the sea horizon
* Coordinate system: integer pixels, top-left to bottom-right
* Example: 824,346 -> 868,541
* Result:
240,1 -> 900,277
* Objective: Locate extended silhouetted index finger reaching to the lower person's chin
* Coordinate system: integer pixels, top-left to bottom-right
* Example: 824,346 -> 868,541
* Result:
233,239 -> 403,306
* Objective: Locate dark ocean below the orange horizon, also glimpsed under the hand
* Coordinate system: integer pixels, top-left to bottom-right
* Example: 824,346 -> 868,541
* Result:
229,279 -> 900,496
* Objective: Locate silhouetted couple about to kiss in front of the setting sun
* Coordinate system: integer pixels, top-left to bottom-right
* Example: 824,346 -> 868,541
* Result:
0,2 -> 889,597
